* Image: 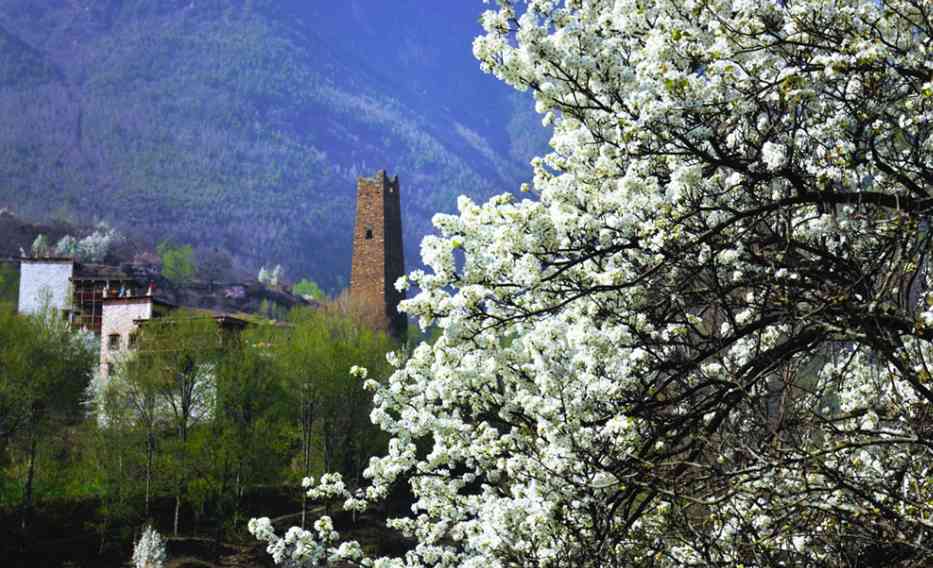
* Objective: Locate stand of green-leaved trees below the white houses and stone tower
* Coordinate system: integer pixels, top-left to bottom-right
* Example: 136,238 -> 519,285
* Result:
0,300 -> 396,547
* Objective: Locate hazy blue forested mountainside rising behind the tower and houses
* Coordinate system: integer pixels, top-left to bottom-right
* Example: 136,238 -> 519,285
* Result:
0,0 -> 545,290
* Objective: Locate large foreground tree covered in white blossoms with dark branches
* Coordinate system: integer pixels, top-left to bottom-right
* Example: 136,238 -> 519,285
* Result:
252,0 -> 933,568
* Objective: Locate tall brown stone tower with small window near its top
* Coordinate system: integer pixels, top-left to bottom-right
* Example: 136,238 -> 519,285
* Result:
350,170 -> 407,339
